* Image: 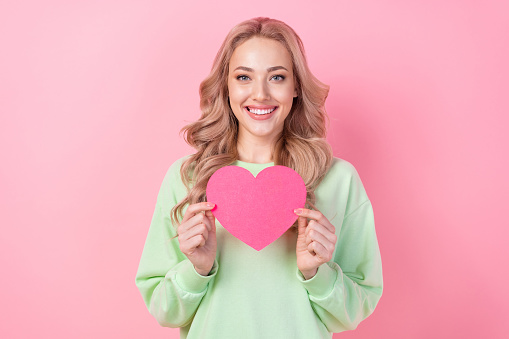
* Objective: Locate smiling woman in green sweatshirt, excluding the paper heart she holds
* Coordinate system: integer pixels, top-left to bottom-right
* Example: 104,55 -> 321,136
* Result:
136,18 -> 382,339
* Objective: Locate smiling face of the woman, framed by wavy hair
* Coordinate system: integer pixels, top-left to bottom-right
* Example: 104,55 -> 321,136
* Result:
228,37 -> 297,142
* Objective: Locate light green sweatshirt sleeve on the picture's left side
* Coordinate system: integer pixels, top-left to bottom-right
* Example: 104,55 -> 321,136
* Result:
135,163 -> 218,327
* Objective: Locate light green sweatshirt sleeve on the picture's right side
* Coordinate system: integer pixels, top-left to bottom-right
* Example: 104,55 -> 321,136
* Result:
297,163 -> 383,333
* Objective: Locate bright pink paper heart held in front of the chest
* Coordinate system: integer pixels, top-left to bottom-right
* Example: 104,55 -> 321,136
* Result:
207,166 -> 306,251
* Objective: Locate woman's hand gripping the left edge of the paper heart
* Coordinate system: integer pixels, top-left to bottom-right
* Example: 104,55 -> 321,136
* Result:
177,202 -> 217,275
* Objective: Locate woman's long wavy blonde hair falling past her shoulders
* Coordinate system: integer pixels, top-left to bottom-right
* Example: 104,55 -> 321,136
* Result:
171,18 -> 332,230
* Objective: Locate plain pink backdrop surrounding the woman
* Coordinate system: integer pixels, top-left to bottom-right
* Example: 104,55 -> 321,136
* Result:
0,0 -> 509,339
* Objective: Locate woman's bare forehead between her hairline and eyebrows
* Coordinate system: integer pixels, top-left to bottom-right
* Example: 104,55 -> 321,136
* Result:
229,37 -> 293,72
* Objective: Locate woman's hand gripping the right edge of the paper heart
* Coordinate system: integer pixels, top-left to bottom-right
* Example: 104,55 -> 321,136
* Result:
294,208 -> 337,280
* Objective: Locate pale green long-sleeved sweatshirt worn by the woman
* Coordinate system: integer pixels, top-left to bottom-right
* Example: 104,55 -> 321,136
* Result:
136,158 -> 382,339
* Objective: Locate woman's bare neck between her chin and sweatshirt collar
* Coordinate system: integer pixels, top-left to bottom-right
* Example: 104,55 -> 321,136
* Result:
237,131 -> 276,164
